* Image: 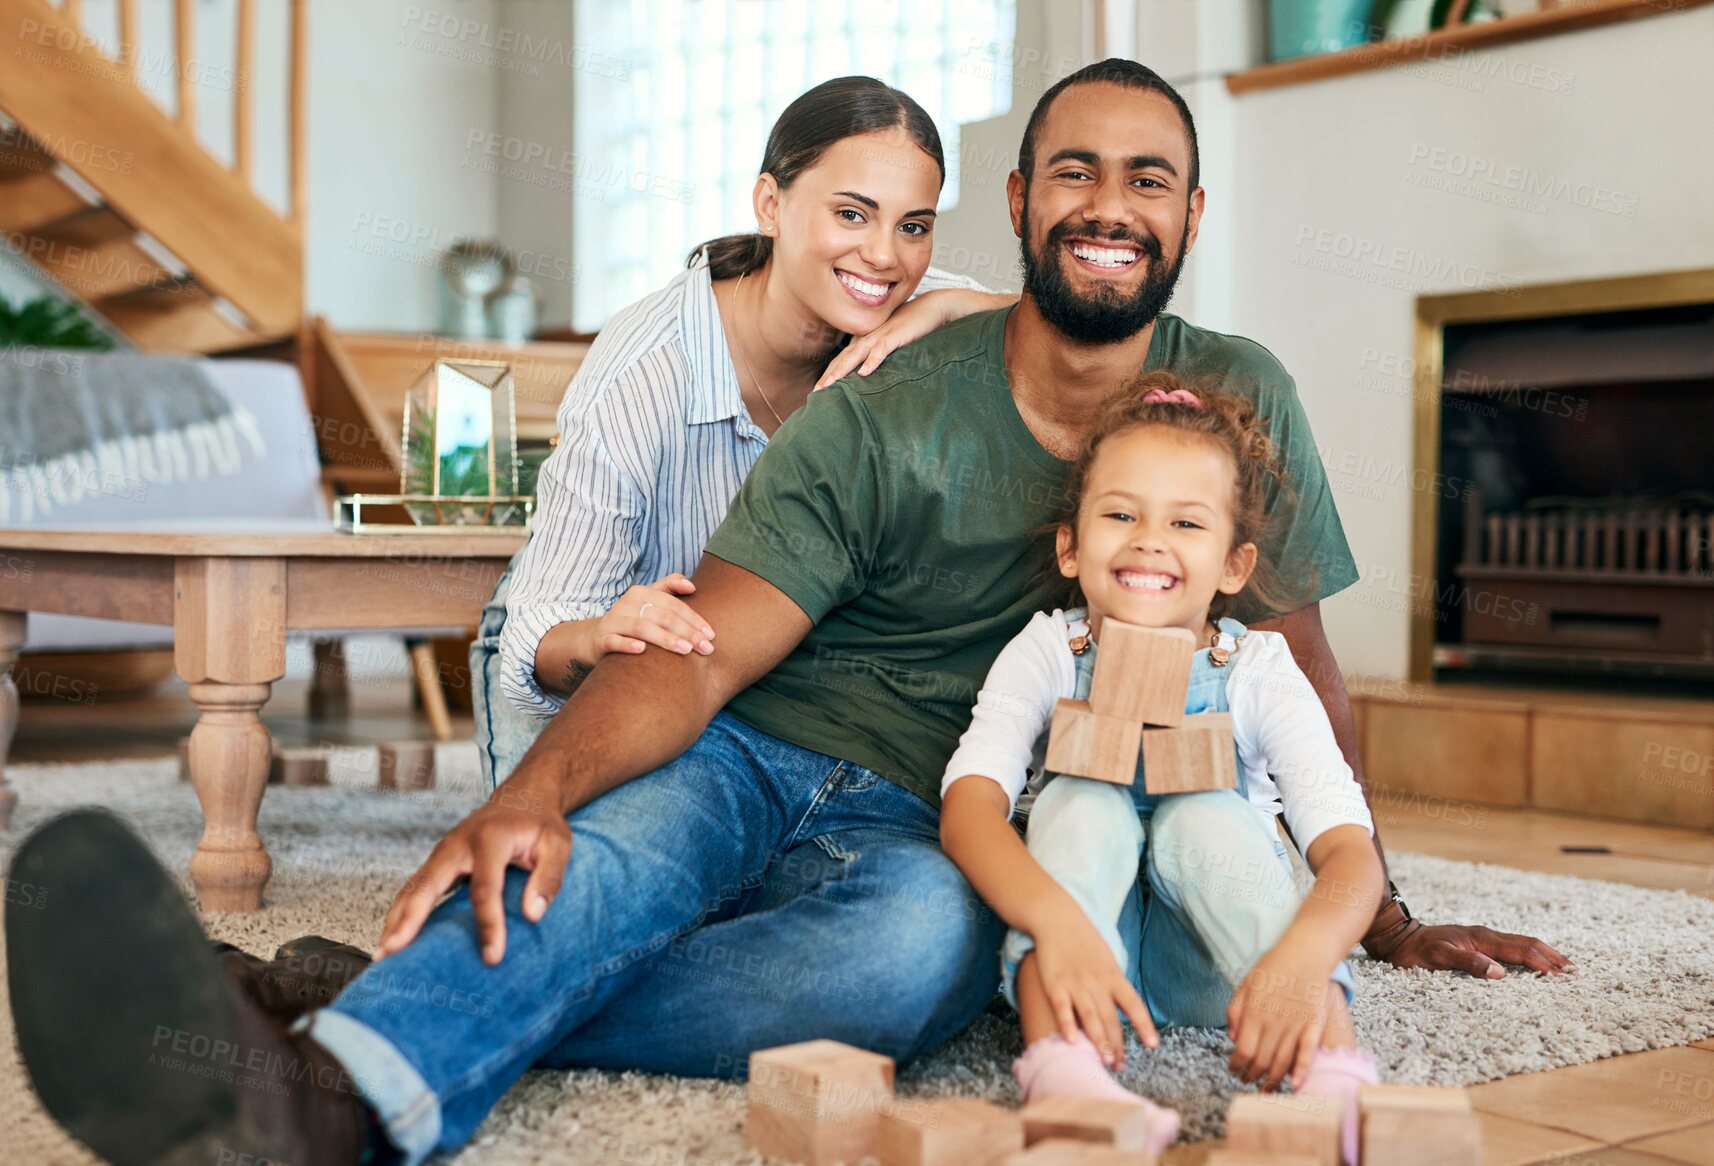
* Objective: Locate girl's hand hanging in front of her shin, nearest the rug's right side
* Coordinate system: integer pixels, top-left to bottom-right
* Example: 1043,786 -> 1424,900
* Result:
1226,943 -> 1332,1091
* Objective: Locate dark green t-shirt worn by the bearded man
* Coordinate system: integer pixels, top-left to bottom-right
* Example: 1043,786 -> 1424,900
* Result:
708,309 -> 1357,804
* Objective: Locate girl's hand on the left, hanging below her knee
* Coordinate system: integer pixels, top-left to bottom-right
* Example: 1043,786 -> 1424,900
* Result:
1035,912 -> 1160,1068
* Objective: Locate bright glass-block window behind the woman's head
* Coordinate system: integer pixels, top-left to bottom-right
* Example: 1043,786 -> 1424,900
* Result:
572,0 -> 1016,331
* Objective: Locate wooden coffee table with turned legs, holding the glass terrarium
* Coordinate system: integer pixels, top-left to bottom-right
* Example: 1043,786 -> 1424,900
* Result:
0,523 -> 524,911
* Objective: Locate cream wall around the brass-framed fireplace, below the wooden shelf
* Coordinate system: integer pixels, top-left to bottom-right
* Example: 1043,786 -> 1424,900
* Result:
1210,9 -> 1714,676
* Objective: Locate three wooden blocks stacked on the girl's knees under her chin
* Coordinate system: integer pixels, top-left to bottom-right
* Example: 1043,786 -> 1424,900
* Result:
1044,617 -> 1238,794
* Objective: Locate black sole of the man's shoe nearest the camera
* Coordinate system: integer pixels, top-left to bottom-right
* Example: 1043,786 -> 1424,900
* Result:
5,811 -> 266,1166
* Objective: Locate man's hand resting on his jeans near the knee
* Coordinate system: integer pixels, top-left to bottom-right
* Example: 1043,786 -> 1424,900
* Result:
375,782 -> 571,965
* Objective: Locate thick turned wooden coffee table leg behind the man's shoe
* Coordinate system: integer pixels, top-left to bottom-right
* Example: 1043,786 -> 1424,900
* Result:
173,557 -> 286,911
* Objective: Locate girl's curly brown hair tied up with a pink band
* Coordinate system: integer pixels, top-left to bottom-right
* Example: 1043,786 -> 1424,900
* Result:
1035,370 -> 1299,619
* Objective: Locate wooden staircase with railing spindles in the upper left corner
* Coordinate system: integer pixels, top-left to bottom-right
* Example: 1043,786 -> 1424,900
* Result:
0,0 -> 307,353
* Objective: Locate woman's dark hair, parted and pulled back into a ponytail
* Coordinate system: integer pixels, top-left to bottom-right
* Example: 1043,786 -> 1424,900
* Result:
684,77 -> 946,279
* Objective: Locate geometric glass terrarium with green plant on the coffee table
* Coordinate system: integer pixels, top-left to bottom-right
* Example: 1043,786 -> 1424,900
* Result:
399,360 -> 530,526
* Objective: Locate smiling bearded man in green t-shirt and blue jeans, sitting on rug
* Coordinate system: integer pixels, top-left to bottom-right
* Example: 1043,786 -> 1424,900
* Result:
7,60 -> 1563,1164
